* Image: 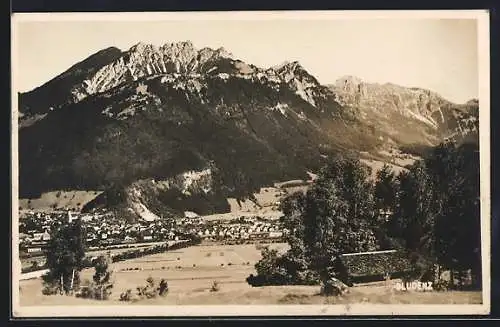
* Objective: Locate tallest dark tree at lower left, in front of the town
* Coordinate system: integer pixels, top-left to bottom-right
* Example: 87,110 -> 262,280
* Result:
43,219 -> 85,294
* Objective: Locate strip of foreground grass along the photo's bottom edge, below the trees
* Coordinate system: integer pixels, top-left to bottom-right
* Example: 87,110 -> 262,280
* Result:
21,280 -> 482,306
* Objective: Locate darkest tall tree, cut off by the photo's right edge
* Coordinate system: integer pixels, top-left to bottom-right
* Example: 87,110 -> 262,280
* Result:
427,142 -> 481,285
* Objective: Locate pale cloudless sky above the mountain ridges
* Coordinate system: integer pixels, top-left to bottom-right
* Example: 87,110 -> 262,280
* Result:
13,14 -> 479,103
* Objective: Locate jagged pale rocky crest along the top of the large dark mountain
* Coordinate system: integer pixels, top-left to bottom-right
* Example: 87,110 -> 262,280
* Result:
20,40 -> 325,118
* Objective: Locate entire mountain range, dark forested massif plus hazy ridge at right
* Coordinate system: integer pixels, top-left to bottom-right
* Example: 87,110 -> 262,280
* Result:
15,42 -> 478,219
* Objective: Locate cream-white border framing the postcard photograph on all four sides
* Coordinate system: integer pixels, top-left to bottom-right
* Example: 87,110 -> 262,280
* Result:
11,10 -> 491,317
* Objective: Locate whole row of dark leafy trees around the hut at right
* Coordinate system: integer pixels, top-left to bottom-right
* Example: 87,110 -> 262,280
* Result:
247,142 -> 481,288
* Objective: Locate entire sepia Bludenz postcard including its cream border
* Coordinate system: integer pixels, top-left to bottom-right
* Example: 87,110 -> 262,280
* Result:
12,10 -> 490,317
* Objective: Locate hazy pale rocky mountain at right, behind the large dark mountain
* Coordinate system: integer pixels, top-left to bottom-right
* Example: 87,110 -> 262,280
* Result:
330,76 -> 478,143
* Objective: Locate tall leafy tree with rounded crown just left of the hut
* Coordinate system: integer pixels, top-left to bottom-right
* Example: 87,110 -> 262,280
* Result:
304,156 -> 376,284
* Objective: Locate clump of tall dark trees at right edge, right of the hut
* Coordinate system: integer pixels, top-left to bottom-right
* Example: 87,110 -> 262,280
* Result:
395,142 -> 481,290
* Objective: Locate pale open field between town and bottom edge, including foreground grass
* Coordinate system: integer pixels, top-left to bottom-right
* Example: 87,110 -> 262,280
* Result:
20,243 -> 481,306
